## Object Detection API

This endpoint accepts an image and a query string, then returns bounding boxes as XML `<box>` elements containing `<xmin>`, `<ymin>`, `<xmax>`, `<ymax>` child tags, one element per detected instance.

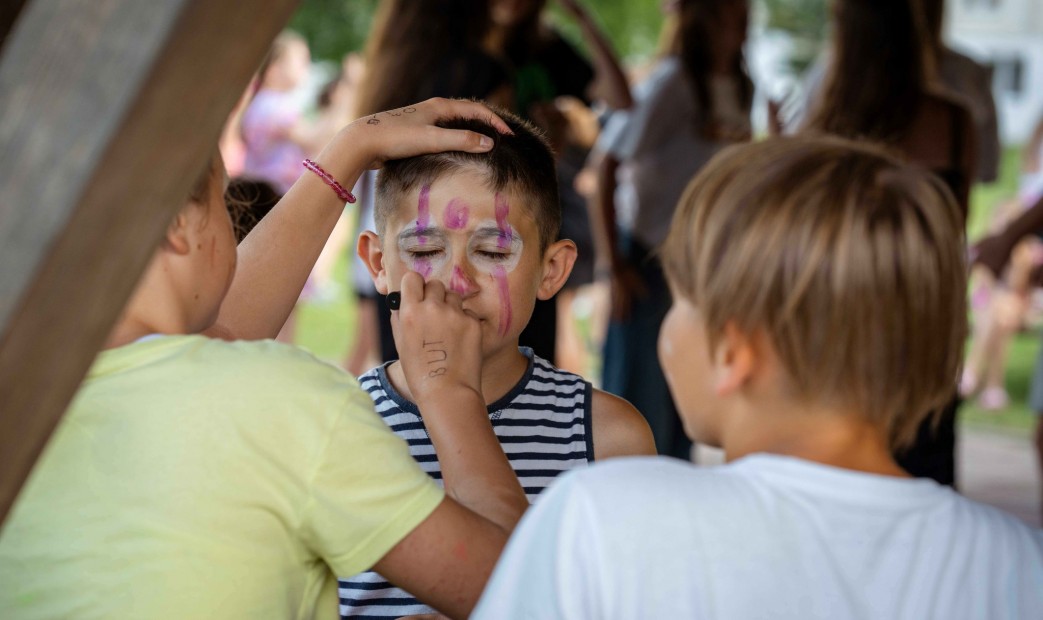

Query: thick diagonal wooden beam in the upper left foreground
<box><xmin>0</xmin><ymin>0</ymin><xmax>296</xmax><ymax>523</ymax></box>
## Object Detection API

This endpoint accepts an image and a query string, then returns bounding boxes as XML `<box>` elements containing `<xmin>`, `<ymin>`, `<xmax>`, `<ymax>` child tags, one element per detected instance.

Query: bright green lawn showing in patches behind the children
<box><xmin>297</xmin><ymin>148</ymin><xmax>1040</xmax><ymax>434</ymax></box>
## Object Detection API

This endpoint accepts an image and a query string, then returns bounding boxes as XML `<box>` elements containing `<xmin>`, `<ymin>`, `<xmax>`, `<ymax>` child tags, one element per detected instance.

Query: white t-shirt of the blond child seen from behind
<box><xmin>472</xmin><ymin>455</ymin><xmax>1043</xmax><ymax>620</ymax></box>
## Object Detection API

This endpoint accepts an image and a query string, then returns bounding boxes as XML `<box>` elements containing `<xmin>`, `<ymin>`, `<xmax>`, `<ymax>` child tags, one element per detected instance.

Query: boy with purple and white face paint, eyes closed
<box><xmin>340</xmin><ymin>113</ymin><xmax>655</xmax><ymax>618</ymax></box>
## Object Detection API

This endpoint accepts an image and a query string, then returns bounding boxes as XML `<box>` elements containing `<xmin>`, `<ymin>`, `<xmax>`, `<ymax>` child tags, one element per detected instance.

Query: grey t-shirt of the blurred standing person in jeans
<box><xmin>598</xmin><ymin>56</ymin><xmax>750</xmax><ymax>248</ymax></box>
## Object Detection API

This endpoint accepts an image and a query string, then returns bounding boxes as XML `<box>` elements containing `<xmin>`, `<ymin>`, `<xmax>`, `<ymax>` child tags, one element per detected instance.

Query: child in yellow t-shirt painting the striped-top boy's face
<box><xmin>0</xmin><ymin>100</ymin><xmax>528</xmax><ymax>618</ymax></box>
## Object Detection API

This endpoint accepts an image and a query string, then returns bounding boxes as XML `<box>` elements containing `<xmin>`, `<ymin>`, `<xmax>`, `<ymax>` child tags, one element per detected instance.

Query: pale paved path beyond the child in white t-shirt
<box><xmin>696</xmin><ymin>427</ymin><xmax>1043</xmax><ymax>527</ymax></box>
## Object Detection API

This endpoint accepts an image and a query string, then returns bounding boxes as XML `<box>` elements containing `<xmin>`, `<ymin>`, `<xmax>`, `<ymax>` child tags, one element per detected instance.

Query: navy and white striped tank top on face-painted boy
<box><xmin>338</xmin><ymin>348</ymin><xmax>593</xmax><ymax>619</ymax></box>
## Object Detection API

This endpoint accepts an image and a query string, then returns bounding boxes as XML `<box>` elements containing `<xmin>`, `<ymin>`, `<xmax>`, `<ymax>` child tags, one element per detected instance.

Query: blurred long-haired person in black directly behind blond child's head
<box><xmin>802</xmin><ymin>0</ymin><xmax>978</xmax><ymax>485</ymax></box>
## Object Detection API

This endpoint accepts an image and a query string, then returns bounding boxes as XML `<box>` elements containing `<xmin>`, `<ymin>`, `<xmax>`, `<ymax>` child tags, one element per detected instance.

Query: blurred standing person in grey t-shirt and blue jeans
<box><xmin>591</xmin><ymin>0</ymin><xmax>753</xmax><ymax>460</ymax></box>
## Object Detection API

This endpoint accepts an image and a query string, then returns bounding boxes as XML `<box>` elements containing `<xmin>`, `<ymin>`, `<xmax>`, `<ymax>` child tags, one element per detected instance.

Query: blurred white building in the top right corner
<box><xmin>946</xmin><ymin>0</ymin><xmax>1043</xmax><ymax>144</ymax></box>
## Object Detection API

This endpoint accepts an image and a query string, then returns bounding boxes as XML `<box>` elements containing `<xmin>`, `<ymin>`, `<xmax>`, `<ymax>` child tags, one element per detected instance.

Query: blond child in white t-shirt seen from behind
<box><xmin>472</xmin><ymin>138</ymin><xmax>1043</xmax><ymax>620</ymax></box>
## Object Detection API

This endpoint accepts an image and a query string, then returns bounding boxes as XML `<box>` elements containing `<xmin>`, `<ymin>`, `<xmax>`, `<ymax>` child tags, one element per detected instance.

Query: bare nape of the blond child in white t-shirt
<box><xmin>721</xmin><ymin>401</ymin><xmax>909</xmax><ymax>477</ymax></box>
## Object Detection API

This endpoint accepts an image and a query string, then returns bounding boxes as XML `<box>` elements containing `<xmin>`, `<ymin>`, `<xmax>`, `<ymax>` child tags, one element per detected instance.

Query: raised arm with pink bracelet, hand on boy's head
<box><xmin>207</xmin><ymin>99</ymin><xmax>510</xmax><ymax>339</ymax></box>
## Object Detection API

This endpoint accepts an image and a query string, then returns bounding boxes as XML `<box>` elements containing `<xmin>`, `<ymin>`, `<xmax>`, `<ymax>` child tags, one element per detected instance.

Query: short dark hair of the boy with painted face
<box><xmin>373</xmin><ymin>110</ymin><xmax>561</xmax><ymax>253</ymax></box>
